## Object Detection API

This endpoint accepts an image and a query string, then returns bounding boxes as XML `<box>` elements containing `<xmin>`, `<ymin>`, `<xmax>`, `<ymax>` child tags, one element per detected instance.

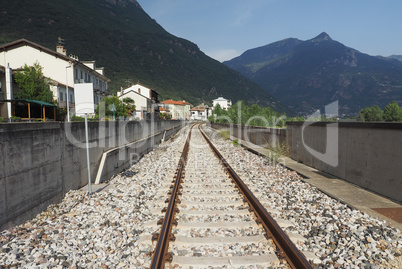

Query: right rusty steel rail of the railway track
<box><xmin>198</xmin><ymin>126</ymin><xmax>313</xmax><ymax>269</ymax></box>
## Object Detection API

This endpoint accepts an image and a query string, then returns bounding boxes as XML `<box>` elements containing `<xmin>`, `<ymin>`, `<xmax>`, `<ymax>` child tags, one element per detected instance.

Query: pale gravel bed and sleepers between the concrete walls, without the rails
<box><xmin>0</xmin><ymin>125</ymin><xmax>402</xmax><ymax>269</ymax></box>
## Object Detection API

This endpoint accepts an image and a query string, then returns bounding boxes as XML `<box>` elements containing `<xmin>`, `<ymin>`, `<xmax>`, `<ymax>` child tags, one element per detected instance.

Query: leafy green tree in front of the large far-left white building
<box><xmin>14</xmin><ymin>62</ymin><xmax>54</xmax><ymax>103</ymax></box>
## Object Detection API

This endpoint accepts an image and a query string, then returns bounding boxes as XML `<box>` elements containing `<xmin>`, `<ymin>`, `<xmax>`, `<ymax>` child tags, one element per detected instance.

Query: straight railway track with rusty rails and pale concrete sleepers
<box><xmin>151</xmin><ymin>126</ymin><xmax>311</xmax><ymax>268</ymax></box>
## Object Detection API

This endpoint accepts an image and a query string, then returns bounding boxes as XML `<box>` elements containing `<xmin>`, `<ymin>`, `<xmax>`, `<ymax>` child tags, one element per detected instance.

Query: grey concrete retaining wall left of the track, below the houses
<box><xmin>0</xmin><ymin>121</ymin><xmax>183</xmax><ymax>231</ymax></box>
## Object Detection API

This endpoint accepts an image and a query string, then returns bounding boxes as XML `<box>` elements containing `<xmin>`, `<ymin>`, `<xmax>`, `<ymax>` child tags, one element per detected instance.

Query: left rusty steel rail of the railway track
<box><xmin>150</xmin><ymin>125</ymin><xmax>194</xmax><ymax>269</ymax></box>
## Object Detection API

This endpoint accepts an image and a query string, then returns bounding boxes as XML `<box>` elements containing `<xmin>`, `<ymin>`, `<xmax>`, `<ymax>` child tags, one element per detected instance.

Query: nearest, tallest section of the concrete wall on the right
<box><xmin>287</xmin><ymin>122</ymin><xmax>402</xmax><ymax>202</ymax></box>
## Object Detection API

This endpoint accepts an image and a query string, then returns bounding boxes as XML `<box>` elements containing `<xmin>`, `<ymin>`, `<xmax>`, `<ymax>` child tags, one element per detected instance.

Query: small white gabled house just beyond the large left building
<box><xmin>117</xmin><ymin>84</ymin><xmax>158</xmax><ymax>120</ymax></box>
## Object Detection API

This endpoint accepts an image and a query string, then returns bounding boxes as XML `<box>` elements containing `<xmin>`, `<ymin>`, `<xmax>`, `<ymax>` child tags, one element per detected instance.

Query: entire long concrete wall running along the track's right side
<box><xmin>211</xmin><ymin>122</ymin><xmax>402</xmax><ymax>203</ymax></box>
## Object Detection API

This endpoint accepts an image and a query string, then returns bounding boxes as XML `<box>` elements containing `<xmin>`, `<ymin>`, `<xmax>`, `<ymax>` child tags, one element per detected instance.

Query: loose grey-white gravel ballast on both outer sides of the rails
<box><xmin>0</xmin><ymin>124</ymin><xmax>402</xmax><ymax>268</ymax></box>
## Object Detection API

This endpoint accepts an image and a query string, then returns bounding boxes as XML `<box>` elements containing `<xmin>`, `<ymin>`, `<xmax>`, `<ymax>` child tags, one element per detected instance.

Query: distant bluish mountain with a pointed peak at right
<box><xmin>224</xmin><ymin>33</ymin><xmax>402</xmax><ymax>115</ymax></box>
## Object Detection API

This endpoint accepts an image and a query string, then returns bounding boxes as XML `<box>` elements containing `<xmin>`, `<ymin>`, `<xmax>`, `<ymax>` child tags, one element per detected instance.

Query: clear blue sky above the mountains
<box><xmin>137</xmin><ymin>0</ymin><xmax>402</xmax><ymax>61</ymax></box>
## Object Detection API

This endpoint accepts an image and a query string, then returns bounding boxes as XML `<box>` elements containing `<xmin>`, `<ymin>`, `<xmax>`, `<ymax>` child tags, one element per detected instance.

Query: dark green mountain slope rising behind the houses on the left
<box><xmin>0</xmin><ymin>0</ymin><xmax>287</xmax><ymax>111</ymax></box>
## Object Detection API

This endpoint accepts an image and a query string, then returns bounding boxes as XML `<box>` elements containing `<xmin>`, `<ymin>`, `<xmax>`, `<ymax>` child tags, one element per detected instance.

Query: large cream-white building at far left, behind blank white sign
<box><xmin>0</xmin><ymin>39</ymin><xmax>110</xmax><ymax>118</ymax></box>
